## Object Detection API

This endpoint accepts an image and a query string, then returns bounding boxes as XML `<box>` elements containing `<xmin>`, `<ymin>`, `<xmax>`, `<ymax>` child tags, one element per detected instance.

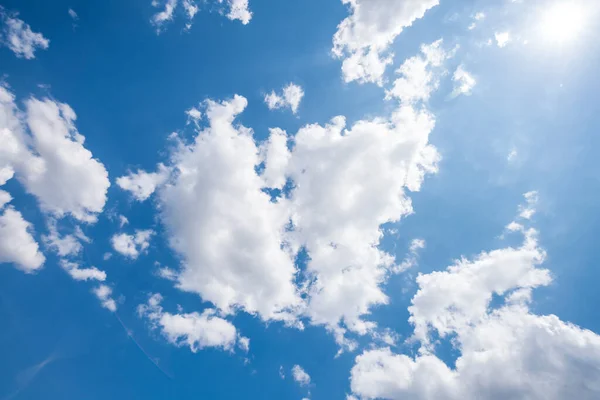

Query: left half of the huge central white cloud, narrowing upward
<box><xmin>158</xmin><ymin>96</ymin><xmax>300</xmax><ymax>319</ymax></box>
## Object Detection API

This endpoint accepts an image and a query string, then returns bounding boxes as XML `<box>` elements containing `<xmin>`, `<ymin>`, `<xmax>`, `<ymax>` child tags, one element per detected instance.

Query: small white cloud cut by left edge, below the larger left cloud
<box><xmin>0</xmin><ymin>206</ymin><xmax>46</xmax><ymax>273</ymax></box>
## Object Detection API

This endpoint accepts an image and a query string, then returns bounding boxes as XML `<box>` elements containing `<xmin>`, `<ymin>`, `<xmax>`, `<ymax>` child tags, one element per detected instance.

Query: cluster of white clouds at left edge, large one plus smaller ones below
<box><xmin>0</xmin><ymin>86</ymin><xmax>110</xmax><ymax>272</ymax></box>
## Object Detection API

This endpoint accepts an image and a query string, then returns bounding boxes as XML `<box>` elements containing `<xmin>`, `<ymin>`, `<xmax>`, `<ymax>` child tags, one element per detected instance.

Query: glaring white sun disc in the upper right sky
<box><xmin>541</xmin><ymin>0</ymin><xmax>586</xmax><ymax>43</ymax></box>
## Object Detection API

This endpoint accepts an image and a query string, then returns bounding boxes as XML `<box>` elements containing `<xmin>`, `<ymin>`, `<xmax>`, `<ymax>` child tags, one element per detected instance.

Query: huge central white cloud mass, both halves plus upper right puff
<box><xmin>117</xmin><ymin>41</ymin><xmax>450</xmax><ymax>348</ymax></box>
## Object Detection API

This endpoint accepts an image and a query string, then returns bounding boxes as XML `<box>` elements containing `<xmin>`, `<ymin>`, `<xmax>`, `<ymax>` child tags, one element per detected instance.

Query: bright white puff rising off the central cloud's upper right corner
<box><xmin>386</xmin><ymin>39</ymin><xmax>450</xmax><ymax>104</ymax></box>
